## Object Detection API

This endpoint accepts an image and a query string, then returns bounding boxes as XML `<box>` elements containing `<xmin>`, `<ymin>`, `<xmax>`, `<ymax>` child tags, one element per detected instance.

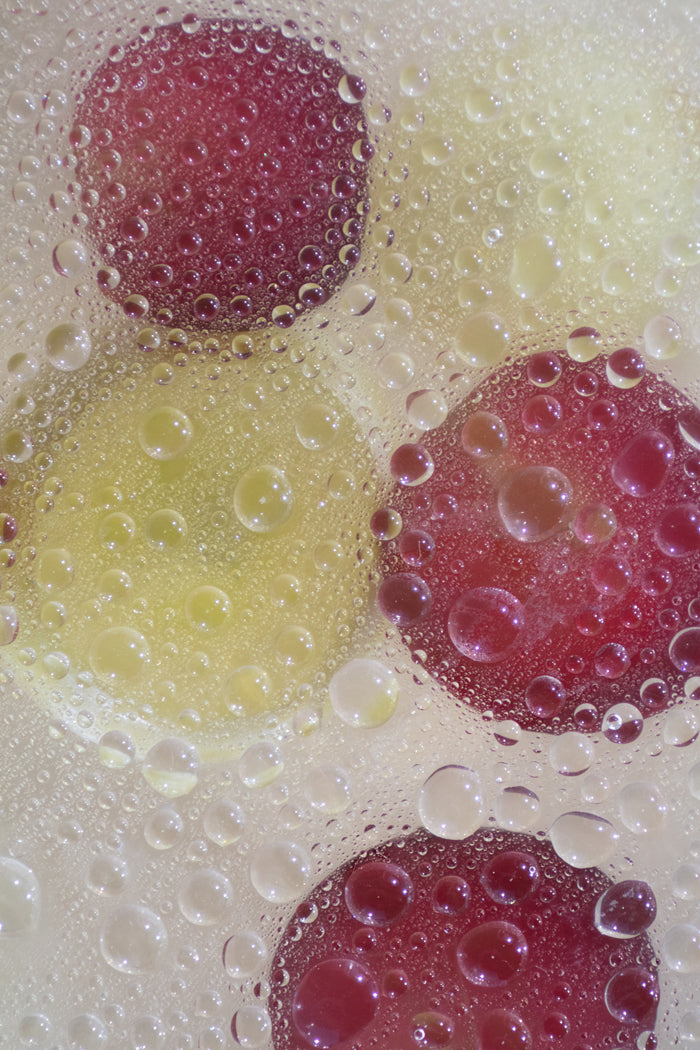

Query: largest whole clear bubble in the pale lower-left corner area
<box><xmin>100</xmin><ymin>904</ymin><xmax>168</xmax><ymax>973</ymax></box>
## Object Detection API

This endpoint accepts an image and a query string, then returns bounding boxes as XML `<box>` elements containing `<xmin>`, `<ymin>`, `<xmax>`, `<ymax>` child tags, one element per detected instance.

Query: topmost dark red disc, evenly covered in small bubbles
<box><xmin>71</xmin><ymin>20</ymin><xmax>373</xmax><ymax>331</ymax></box>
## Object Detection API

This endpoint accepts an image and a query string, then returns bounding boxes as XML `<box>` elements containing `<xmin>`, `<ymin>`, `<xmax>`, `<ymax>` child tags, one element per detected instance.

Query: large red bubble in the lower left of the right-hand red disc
<box><xmin>447</xmin><ymin>587</ymin><xmax>525</xmax><ymax>664</ymax></box>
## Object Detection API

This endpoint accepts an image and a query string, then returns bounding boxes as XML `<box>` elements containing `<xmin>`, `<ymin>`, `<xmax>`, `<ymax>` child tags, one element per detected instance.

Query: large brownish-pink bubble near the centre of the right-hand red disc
<box><xmin>497</xmin><ymin>466</ymin><xmax>573</xmax><ymax>543</ymax></box>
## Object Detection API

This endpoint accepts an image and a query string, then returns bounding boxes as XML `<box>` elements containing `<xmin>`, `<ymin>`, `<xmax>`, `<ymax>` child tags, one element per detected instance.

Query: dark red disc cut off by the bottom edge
<box><xmin>269</xmin><ymin>827</ymin><xmax>658</xmax><ymax>1050</ymax></box>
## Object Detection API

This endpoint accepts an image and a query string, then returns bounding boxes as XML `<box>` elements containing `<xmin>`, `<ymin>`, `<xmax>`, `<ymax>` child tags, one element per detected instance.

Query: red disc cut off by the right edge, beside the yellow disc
<box><xmin>378</xmin><ymin>354</ymin><xmax>700</xmax><ymax>733</ymax></box>
